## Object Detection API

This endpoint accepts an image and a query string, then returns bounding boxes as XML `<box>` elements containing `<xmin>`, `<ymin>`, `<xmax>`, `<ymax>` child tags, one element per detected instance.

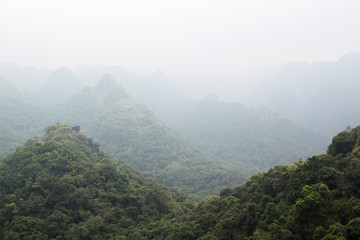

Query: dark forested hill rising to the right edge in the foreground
<box><xmin>172</xmin><ymin>127</ymin><xmax>360</xmax><ymax>240</ymax></box>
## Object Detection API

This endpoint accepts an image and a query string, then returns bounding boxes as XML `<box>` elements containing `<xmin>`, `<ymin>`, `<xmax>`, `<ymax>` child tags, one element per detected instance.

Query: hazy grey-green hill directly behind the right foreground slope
<box><xmin>176</xmin><ymin>94</ymin><xmax>329</xmax><ymax>174</ymax></box>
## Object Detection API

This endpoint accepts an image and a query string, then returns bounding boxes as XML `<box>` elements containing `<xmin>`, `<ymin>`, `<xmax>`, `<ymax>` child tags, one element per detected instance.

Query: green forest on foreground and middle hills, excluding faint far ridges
<box><xmin>0</xmin><ymin>75</ymin><xmax>360</xmax><ymax>240</ymax></box>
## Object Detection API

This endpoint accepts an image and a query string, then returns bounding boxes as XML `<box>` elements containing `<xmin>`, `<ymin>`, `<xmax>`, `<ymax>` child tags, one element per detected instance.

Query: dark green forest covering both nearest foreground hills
<box><xmin>0</xmin><ymin>124</ymin><xmax>360</xmax><ymax>240</ymax></box>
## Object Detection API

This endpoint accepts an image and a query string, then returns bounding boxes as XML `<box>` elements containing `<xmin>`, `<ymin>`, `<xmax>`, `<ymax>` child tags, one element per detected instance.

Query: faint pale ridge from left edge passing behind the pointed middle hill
<box><xmin>0</xmin><ymin>63</ymin><xmax>194</xmax><ymax>122</ymax></box>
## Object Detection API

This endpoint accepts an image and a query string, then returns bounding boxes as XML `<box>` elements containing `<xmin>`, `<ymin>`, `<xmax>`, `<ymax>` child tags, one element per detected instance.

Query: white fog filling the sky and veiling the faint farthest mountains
<box><xmin>0</xmin><ymin>0</ymin><xmax>360</xmax><ymax>132</ymax></box>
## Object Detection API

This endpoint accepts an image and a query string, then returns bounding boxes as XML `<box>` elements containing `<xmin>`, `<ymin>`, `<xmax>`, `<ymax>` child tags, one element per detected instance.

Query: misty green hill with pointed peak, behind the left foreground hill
<box><xmin>47</xmin><ymin>75</ymin><xmax>245</xmax><ymax>194</ymax></box>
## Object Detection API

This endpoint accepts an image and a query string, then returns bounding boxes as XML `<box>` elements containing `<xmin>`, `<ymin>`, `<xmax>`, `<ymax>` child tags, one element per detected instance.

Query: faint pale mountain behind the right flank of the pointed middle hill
<box><xmin>75</xmin><ymin>66</ymin><xmax>195</xmax><ymax>123</ymax></box>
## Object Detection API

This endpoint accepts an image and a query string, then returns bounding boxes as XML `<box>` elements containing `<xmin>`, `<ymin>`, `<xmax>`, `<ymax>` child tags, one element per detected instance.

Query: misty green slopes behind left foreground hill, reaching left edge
<box><xmin>0</xmin><ymin>79</ymin><xmax>247</xmax><ymax>195</ymax></box>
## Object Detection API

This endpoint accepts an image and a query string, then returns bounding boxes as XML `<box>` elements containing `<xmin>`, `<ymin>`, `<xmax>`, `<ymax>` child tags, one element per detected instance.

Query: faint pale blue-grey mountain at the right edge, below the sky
<box><xmin>250</xmin><ymin>52</ymin><xmax>360</xmax><ymax>134</ymax></box>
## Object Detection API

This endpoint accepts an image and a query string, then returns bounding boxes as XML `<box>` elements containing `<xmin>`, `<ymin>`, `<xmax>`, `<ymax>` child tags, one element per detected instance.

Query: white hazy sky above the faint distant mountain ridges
<box><xmin>0</xmin><ymin>0</ymin><xmax>360</xmax><ymax>76</ymax></box>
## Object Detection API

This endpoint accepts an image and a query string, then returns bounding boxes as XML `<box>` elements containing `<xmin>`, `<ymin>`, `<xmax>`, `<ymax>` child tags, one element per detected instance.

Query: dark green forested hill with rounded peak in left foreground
<box><xmin>0</xmin><ymin>124</ymin><xmax>198</xmax><ymax>239</ymax></box>
